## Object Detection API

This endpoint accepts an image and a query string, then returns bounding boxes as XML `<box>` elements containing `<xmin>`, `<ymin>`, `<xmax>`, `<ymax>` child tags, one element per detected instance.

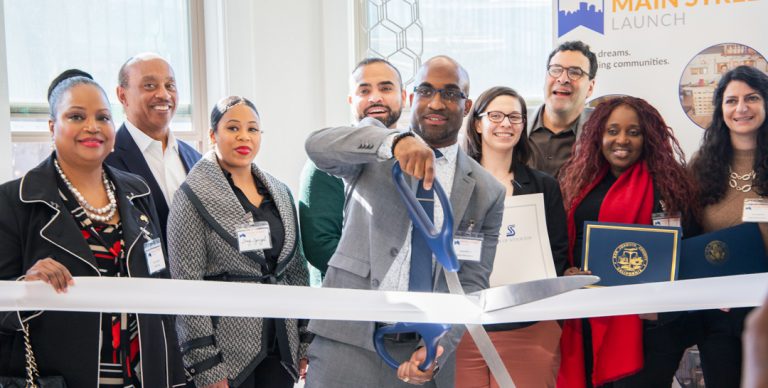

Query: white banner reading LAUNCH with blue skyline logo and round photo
<box><xmin>553</xmin><ymin>0</ymin><xmax>768</xmax><ymax>158</ymax></box>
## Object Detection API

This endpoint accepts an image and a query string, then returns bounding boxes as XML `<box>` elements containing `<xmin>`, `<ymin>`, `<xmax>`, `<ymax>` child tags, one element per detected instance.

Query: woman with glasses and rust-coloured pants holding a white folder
<box><xmin>456</xmin><ymin>86</ymin><xmax>568</xmax><ymax>388</ymax></box>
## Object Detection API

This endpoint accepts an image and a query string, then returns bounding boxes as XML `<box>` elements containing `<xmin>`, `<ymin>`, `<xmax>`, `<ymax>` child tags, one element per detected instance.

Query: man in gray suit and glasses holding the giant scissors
<box><xmin>306</xmin><ymin>56</ymin><xmax>505</xmax><ymax>388</ymax></box>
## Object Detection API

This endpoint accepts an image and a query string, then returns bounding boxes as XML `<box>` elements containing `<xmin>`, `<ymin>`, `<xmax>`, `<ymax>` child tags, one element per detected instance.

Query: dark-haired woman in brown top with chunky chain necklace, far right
<box><xmin>691</xmin><ymin>66</ymin><xmax>768</xmax><ymax>248</ymax></box>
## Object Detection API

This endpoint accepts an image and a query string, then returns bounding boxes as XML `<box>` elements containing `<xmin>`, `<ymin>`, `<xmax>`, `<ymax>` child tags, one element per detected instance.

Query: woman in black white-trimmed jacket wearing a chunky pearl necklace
<box><xmin>0</xmin><ymin>71</ymin><xmax>185</xmax><ymax>387</ymax></box>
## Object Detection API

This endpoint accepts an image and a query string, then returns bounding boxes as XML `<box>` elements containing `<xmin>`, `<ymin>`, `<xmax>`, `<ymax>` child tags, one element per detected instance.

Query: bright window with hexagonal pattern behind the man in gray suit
<box><xmin>357</xmin><ymin>0</ymin><xmax>553</xmax><ymax>104</ymax></box>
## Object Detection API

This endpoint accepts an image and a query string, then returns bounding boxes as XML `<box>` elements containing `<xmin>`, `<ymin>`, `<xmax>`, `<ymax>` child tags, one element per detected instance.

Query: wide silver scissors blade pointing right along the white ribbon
<box><xmin>470</xmin><ymin>275</ymin><xmax>600</xmax><ymax>312</ymax></box>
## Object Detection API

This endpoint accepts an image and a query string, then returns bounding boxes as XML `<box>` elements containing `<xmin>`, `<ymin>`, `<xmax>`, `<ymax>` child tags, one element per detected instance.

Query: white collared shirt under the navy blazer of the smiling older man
<box><xmin>125</xmin><ymin>120</ymin><xmax>187</xmax><ymax>207</ymax></box>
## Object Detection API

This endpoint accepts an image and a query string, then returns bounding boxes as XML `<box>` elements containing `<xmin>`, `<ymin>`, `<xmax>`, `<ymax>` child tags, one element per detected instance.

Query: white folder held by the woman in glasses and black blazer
<box><xmin>491</xmin><ymin>193</ymin><xmax>557</xmax><ymax>287</ymax></box>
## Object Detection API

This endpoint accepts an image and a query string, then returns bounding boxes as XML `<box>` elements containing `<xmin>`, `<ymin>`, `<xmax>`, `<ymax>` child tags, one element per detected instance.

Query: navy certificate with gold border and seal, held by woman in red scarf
<box><xmin>582</xmin><ymin>221</ymin><xmax>682</xmax><ymax>286</ymax></box>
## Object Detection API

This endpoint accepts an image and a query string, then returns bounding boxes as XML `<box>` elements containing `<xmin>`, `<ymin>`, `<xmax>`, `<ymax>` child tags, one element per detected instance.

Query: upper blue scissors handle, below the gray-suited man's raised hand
<box><xmin>392</xmin><ymin>161</ymin><xmax>459</xmax><ymax>272</ymax></box>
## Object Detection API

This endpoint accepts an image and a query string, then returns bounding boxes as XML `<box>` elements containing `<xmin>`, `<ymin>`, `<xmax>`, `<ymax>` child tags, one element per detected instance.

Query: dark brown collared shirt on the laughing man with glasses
<box><xmin>528</xmin><ymin>105</ymin><xmax>592</xmax><ymax>177</ymax></box>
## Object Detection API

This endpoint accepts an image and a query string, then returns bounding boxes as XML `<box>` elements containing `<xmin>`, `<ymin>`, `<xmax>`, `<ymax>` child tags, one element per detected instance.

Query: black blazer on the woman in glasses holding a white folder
<box><xmin>512</xmin><ymin>164</ymin><xmax>568</xmax><ymax>276</ymax></box>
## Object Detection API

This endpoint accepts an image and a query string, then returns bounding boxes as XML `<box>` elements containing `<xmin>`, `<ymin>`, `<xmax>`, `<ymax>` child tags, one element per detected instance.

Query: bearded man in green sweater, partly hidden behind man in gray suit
<box><xmin>299</xmin><ymin>58</ymin><xmax>405</xmax><ymax>276</ymax></box>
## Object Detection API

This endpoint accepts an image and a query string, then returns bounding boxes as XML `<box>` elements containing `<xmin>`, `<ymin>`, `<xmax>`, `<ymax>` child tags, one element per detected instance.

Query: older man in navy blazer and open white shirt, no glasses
<box><xmin>106</xmin><ymin>53</ymin><xmax>201</xmax><ymax>240</ymax></box>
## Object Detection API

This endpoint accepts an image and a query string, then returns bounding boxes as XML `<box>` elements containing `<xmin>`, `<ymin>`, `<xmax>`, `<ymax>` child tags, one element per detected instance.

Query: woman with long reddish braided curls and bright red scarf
<box><xmin>558</xmin><ymin>97</ymin><xmax>696</xmax><ymax>388</ymax></box>
